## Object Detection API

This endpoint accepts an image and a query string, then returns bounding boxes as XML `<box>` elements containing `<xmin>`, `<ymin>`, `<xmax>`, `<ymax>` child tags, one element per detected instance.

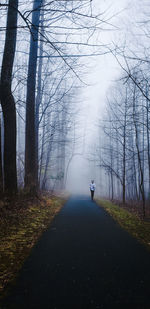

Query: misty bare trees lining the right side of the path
<box><xmin>86</xmin><ymin>4</ymin><xmax>150</xmax><ymax>217</ymax></box>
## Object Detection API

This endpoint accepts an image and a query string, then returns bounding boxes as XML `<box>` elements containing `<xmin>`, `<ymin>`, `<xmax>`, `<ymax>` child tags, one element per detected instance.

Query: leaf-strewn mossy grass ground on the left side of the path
<box><xmin>0</xmin><ymin>196</ymin><xmax>65</xmax><ymax>297</ymax></box>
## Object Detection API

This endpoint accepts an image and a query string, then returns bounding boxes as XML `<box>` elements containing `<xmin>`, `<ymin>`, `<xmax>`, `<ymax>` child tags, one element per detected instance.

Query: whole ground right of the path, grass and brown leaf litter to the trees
<box><xmin>97</xmin><ymin>199</ymin><xmax>150</xmax><ymax>250</ymax></box>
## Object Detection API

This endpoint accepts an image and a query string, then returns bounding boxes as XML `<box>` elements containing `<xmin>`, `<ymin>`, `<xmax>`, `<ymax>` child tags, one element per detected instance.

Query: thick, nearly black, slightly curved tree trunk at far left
<box><xmin>1</xmin><ymin>0</ymin><xmax>18</xmax><ymax>194</ymax></box>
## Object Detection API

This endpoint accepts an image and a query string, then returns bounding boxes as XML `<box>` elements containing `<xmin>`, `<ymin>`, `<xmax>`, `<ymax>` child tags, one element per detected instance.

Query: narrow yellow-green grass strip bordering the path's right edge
<box><xmin>97</xmin><ymin>199</ymin><xmax>150</xmax><ymax>249</ymax></box>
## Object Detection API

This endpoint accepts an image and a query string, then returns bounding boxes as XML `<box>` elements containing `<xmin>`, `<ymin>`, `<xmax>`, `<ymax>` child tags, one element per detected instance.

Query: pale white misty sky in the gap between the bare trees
<box><xmin>68</xmin><ymin>0</ymin><xmax>143</xmax><ymax>193</ymax></box>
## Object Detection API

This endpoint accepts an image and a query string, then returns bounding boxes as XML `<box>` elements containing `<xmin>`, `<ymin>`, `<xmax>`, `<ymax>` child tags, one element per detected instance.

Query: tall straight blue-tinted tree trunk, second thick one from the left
<box><xmin>25</xmin><ymin>0</ymin><xmax>42</xmax><ymax>194</ymax></box>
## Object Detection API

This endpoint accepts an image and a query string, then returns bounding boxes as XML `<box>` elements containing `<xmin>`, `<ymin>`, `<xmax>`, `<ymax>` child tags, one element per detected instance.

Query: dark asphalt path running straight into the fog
<box><xmin>2</xmin><ymin>197</ymin><xmax>150</xmax><ymax>309</ymax></box>
